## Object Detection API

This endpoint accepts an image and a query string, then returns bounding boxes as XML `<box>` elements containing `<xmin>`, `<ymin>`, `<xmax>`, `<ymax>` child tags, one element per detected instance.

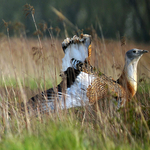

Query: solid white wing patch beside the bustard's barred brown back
<box><xmin>61</xmin><ymin>72</ymin><xmax>95</xmax><ymax>109</ymax></box>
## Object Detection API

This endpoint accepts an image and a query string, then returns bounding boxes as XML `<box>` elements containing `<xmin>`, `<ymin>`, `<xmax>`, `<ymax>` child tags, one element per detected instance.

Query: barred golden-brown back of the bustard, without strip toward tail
<box><xmin>87</xmin><ymin>75</ymin><xmax>126</xmax><ymax>107</ymax></box>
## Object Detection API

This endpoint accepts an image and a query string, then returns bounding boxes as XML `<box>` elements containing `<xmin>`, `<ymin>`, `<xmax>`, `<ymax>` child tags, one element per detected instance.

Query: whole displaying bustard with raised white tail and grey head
<box><xmin>30</xmin><ymin>34</ymin><xmax>148</xmax><ymax>111</ymax></box>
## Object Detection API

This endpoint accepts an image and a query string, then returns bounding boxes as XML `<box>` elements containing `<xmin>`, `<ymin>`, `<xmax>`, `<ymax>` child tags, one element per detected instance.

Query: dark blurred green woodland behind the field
<box><xmin>0</xmin><ymin>0</ymin><xmax>150</xmax><ymax>42</ymax></box>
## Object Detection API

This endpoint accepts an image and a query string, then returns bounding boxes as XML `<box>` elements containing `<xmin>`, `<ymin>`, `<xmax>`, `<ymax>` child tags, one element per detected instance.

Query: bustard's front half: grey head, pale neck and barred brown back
<box><xmin>87</xmin><ymin>48</ymin><xmax>148</xmax><ymax>108</ymax></box>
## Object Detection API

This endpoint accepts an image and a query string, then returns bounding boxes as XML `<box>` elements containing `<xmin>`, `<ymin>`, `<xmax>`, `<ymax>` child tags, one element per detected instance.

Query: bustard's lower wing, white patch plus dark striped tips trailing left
<box><xmin>30</xmin><ymin>69</ymin><xmax>95</xmax><ymax>111</ymax></box>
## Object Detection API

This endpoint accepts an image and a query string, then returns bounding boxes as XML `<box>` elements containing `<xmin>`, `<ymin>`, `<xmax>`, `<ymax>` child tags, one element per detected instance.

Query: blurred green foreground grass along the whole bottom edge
<box><xmin>0</xmin><ymin>116</ymin><xmax>148</xmax><ymax>150</ymax></box>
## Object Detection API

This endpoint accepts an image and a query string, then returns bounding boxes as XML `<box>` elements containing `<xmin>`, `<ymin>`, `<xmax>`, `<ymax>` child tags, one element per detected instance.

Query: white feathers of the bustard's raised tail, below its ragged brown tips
<box><xmin>62</xmin><ymin>43</ymin><xmax>88</xmax><ymax>71</ymax></box>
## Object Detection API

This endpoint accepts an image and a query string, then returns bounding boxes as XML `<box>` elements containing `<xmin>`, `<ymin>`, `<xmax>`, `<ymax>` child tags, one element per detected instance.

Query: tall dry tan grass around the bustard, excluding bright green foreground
<box><xmin>0</xmin><ymin>33</ymin><xmax>150</xmax><ymax>148</ymax></box>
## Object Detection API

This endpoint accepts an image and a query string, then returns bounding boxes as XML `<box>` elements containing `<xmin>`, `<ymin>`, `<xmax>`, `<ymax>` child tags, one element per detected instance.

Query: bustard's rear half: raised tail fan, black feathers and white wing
<box><xmin>29</xmin><ymin>34</ymin><xmax>94</xmax><ymax>111</ymax></box>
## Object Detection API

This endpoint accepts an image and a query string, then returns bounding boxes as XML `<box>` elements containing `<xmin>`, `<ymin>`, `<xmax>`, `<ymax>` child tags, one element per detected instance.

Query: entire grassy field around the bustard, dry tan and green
<box><xmin>0</xmin><ymin>33</ymin><xmax>150</xmax><ymax>150</ymax></box>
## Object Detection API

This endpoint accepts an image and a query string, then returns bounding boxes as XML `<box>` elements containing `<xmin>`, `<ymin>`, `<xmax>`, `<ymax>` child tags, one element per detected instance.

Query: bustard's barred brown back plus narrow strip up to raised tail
<box><xmin>70</xmin><ymin>60</ymin><xmax>127</xmax><ymax>108</ymax></box>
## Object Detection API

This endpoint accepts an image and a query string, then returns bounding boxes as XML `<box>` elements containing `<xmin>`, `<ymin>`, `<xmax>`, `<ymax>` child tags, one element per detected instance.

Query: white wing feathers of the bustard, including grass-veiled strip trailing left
<box><xmin>42</xmin><ymin>72</ymin><xmax>95</xmax><ymax>111</ymax></box>
